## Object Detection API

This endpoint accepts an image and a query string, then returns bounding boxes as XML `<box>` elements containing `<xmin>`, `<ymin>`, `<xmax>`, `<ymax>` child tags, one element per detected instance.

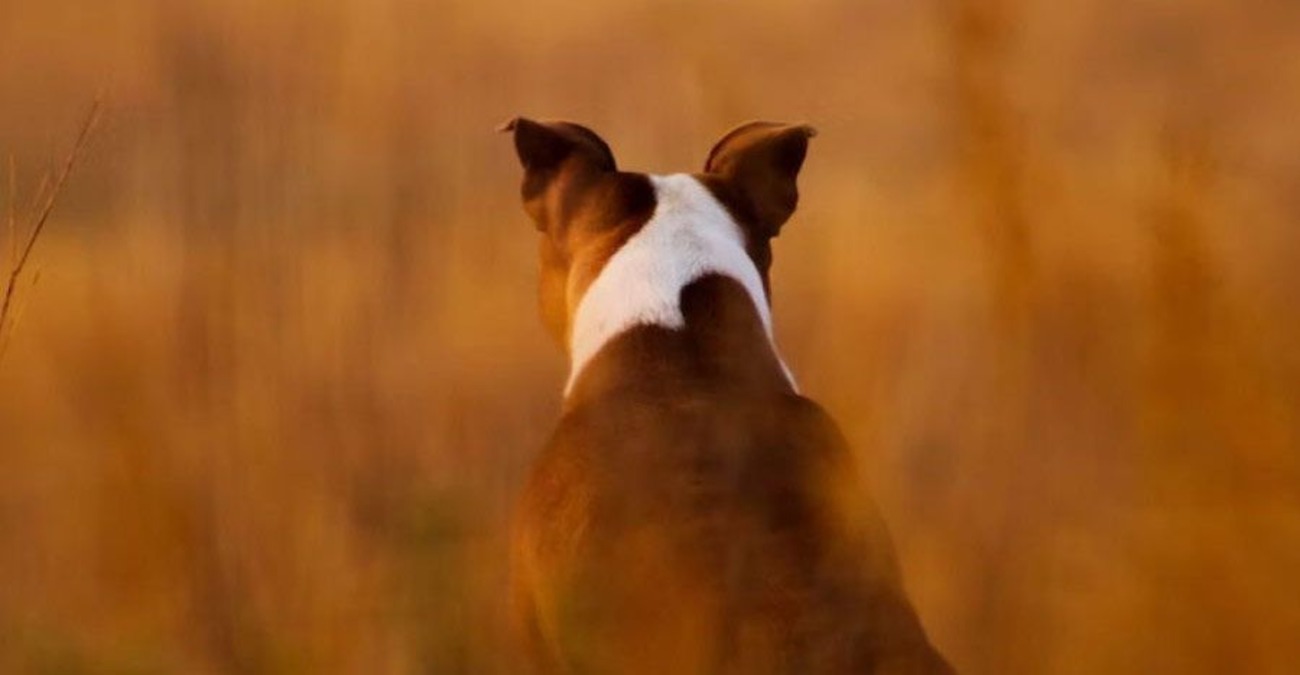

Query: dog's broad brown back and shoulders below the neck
<box><xmin>516</xmin><ymin>394</ymin><xmax>945</xmax><ymax>674</ymax></box>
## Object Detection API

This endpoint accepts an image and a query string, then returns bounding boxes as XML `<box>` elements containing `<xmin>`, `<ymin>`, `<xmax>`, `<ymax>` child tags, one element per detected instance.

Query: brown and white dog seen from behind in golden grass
<box><xmin>503</xmin><ymin>118</ymin><xmax>952</xmax><ymax>675</ymax></box>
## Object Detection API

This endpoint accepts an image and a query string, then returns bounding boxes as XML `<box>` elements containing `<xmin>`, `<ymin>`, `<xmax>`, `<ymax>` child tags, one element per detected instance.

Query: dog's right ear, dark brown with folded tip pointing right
<box><xmin>705</xmin><ymin>122</ymin><xmax>816</xmax><ymax>237</ymax></box>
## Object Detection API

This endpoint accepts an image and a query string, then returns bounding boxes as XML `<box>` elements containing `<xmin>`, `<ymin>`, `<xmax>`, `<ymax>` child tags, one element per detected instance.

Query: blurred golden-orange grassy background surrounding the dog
<box><xmin>0</xmin><ymin>0</ymin><xmax>1300</xmax><ymax>674</ymax></box>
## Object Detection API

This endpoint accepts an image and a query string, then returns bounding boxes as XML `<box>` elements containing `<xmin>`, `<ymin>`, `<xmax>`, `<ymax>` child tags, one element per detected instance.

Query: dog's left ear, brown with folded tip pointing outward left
<box><xmin>498</xmin><ymin>117</ymin><xmax>618</xmax><ymax>232</ymax></box>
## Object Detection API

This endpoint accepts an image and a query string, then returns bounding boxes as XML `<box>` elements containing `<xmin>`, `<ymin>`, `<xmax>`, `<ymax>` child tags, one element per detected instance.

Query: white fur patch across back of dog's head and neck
<box><xmin>564</xmin><ymin>174</ymin><xmax>794</xmax><ymax>395</ymax></box>
